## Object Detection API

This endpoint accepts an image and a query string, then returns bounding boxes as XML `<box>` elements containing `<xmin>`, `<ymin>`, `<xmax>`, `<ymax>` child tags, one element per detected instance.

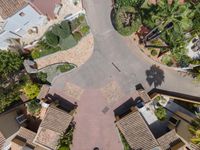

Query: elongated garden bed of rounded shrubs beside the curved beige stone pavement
<box><xmin>31</xmin><ymin>14</ymin><xmax>89</xmax><ymax>59</ymax></box>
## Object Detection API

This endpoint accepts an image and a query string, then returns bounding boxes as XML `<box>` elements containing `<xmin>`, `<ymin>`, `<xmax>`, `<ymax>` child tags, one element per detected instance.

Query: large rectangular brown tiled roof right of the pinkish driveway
<box><xmin>116</xmin><ymin>112</ymin><xmax>159</xmax><ymax>150</ymax></box>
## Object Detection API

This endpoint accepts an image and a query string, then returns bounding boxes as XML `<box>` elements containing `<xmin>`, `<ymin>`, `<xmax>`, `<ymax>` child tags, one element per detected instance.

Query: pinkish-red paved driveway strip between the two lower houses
<box><xmin>72</xmin><ymin>90</ymin><xmax>123</xmax><ymax>150</ymax></box>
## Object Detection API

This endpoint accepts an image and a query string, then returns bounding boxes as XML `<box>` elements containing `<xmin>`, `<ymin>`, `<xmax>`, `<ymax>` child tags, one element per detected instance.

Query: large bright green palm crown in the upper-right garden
<box><xmin>152</xmin><ymin>0</ymin><xmax>194</xmax><ymax>32</ymax></box>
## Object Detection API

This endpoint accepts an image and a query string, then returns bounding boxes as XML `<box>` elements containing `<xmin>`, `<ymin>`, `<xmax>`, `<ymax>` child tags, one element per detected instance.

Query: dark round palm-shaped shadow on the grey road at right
<box><xmin>146</xmin><ymin>65</ymin><xmax>165</xmax><ymax>88</ymax></box>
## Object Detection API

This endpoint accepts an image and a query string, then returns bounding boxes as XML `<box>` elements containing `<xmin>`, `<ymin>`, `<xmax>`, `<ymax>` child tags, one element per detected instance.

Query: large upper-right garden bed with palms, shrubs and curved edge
<box><xmin>113</xmin><ymin>0</ymin><xmax>200</xmax><ymax>67</ymax></box>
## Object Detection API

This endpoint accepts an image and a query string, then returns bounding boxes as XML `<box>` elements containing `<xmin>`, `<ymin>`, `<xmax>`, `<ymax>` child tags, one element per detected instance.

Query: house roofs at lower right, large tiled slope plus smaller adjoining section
<box><xmin>116</xmin><ymin>109</ymin><xmax>188</xmax><ymax>150</ymax></box>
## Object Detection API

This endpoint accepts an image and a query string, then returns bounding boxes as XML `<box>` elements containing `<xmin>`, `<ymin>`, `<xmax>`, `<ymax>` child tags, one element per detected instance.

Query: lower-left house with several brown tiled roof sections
<box><xmin>0</xmin><ymin>105</ymin><xmax>73</xmax><ymax>150</ymax></box>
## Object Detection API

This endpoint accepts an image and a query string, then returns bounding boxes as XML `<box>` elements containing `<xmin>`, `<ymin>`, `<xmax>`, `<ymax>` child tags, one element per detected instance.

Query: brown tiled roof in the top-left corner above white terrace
<box><xmin>0</xmin><ymin>0</ymin><xmax>27</xmax><ymax>19</ymax></box>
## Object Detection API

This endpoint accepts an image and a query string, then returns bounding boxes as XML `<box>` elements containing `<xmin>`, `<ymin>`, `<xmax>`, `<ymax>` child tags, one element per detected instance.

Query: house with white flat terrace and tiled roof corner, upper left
<box><xmin>0</xmin><ymin>0</ymin><xmax>46</xmax><ymax>49</ymax></box>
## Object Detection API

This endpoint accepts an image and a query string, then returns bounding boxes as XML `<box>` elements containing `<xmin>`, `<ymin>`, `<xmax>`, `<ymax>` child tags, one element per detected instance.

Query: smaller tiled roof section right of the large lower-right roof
<box><xmin>157</xmin><ymin>130</ymin><xmax>184</xmax><ymax>150</ymax></box>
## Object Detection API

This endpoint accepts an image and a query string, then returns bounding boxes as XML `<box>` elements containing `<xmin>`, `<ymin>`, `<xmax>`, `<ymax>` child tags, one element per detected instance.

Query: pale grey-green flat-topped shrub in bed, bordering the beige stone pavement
<box><xmin>59</xmin><ymin>35</ymin><xmax>77</xmax><ymax>50</ymax></box>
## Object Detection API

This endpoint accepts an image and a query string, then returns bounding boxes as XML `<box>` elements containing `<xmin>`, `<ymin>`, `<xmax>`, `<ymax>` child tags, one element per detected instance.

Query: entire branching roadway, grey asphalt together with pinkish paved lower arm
<box><xmin>51</xmin><ymin>0</ymin><xmax>200</xmax><ymax>150</ymax></box>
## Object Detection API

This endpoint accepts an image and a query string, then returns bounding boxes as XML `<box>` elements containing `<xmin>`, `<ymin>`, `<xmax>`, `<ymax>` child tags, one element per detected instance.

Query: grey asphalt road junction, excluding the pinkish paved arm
<box><xmin>53</xmin><ymin>0</ymin><xmax>200</xmax><ymax>96</ymax></box>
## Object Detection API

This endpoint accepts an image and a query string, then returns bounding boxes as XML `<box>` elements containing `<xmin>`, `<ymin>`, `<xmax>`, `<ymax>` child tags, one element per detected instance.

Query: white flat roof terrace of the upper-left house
<box><xmin>0</xmin><ymin>5</ymin><xmax>46</xmax><ymax>49</ymax></box>
